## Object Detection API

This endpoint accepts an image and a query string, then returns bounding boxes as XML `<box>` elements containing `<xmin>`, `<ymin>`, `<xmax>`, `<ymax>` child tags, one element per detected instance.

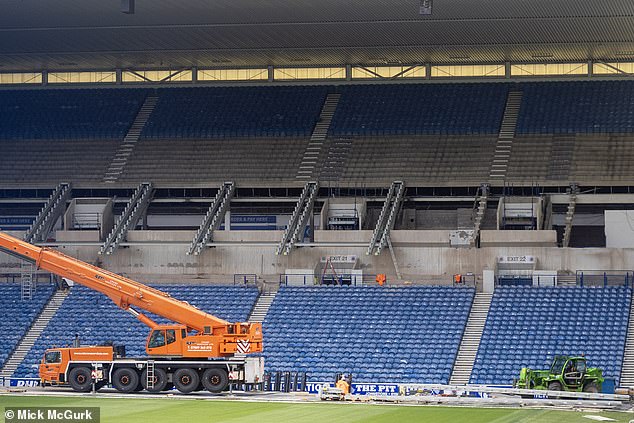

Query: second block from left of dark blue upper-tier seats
<box><xmin>143</xmin><ymin>86</ymin><xmax>328</xmax><ymax>138</ymax></box>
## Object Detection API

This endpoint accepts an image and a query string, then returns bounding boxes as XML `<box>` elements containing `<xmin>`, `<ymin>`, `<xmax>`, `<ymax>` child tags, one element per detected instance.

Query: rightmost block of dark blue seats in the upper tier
<box><xmin>517</xmin><ymin>81</ymin><xmax>634</xmax><ymax>134</ymax></box>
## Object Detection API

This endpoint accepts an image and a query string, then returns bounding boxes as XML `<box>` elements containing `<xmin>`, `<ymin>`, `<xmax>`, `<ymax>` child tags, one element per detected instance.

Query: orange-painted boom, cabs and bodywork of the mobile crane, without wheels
<box><xmin>0</xmin><ymin>232</ymin><xmax>262</xmax><ymax>388</ymax></box>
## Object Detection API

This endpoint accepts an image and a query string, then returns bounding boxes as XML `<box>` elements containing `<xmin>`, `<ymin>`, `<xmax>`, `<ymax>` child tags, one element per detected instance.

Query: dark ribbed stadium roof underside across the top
<box><xmin>0</xmin><ymin>0</ymin><xmax>634</xmax><ymax>72</ymax></box>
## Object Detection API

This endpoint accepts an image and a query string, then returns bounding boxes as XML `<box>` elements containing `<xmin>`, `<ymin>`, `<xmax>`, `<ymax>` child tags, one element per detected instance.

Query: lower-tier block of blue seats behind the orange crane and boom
<box><xmin>14</xmin><ymin>284</ymin><xmax>258</xmax><ymax>377</ymax></box>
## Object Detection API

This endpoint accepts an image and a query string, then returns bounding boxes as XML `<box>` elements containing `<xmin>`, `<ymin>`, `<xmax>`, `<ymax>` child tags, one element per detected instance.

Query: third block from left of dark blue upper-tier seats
<box><xmin>330</xmin><ymin>84</ymin><xmax>508</xmax><ymax>135</ymax></box>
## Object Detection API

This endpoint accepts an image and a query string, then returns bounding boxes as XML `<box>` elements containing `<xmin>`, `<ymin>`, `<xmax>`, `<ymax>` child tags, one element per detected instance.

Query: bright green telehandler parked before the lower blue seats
<box><xmin>513</xmin><ymin>355</ymin><xmax>604</xmax><ymax>393</ymax></box>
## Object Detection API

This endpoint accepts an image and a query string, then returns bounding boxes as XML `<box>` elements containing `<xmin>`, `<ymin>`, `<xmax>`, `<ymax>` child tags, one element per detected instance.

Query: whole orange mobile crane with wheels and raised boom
<box><xmin>0</xmin><ymin>232</ymin><xmax>264</xmax><ymax>393</ymax></box>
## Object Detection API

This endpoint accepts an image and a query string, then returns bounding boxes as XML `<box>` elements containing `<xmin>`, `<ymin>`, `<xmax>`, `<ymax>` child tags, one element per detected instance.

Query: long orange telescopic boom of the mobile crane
<box><xmin>0</xmin><ymin>232</ymin><xmax>231</xmax><ymax>333</ymax></box>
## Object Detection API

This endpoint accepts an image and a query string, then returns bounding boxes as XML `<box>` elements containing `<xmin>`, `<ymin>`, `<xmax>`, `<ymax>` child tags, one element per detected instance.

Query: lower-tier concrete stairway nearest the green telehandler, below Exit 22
<box><xmin>449</xmin><ymin>292</ymin><xmax>493</xmax><ymax>385</ymax></box>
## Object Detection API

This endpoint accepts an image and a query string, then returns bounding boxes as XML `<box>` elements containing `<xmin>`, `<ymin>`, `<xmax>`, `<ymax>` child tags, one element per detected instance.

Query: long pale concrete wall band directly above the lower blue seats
<box><xmin>63</xmin><ymin>244</ymin><xmax>634</xmax><ymax>281</ymax></box>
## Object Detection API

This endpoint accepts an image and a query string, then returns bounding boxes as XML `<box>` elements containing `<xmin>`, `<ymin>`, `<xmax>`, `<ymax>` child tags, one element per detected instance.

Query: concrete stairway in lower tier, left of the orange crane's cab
<box><xmin>0</xmin><ymin>291</ymin><xmax>69</xmax><ymax>378</ymax></box>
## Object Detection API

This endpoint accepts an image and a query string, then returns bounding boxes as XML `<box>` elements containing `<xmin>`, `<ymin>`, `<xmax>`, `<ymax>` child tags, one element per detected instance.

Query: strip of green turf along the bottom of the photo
<box><xmin>0</xmin><ymin>395</ymin><xmax>634</xmax><ymax>423</ymax></box>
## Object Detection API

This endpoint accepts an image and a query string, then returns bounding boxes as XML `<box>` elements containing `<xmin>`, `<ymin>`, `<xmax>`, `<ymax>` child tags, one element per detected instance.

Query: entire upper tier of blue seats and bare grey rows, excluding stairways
<box><xmin>0</xmin><ymin>81</ymin><xmax>634</xmax><ymax>185</ymax></box>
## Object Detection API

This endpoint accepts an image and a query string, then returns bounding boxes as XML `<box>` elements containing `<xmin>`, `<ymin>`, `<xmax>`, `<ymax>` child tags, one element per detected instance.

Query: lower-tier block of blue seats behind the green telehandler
<box><xmin>471</xmin><ymin>287</ymin><xmax>632</xmax><ymax>385</ymax></box>
